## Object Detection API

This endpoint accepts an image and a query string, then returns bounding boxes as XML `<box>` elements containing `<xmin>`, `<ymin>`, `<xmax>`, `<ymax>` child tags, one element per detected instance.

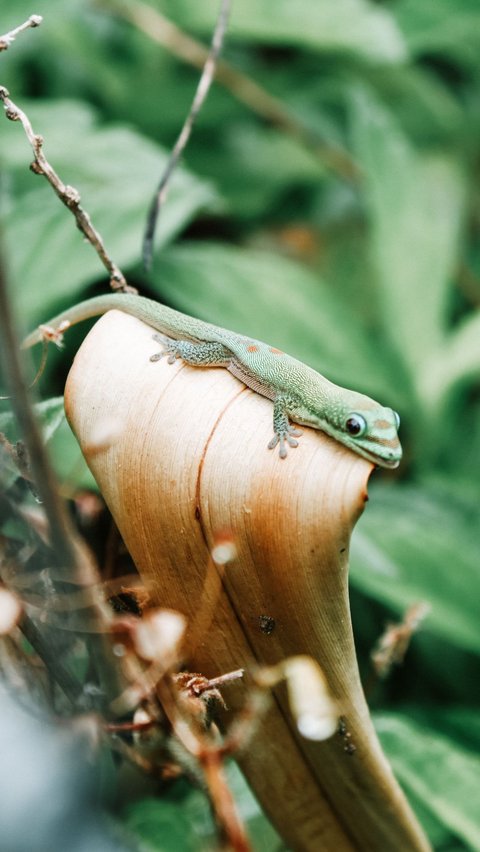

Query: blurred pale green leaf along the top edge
<box><xmin>159</xmin><ymin>0</ymin><xmax>406</xmax><ymax>62</ymax></box>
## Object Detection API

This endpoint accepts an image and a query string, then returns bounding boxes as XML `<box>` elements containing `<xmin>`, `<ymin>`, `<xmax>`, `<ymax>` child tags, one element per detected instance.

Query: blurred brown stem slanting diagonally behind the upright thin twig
<box><xmin>97</xmin><ymin>0</ymin><xmax>359</xmax><ymax>183</ymax></box>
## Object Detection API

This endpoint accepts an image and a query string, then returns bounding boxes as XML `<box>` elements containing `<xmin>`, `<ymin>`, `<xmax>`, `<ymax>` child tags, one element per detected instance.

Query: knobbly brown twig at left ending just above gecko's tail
<box><xmin>0</xmin><ymin>86</ymin><xmax>137</xmax><ymax>293</ymax></box>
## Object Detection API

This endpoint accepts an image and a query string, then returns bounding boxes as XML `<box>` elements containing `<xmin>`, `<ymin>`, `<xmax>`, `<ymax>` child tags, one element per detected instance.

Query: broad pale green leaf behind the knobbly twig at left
<box><xmin>0</xmin><ymin>101</ymin><xmax>217</xmax><ymax>325</ymax></box>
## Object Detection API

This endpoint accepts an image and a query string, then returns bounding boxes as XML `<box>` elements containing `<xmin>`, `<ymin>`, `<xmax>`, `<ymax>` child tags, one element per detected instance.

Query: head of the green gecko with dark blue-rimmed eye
<box><xmin>316</xmin><ymin>391</ymin><xmax>402</xmax><ymax>468</ymax></box>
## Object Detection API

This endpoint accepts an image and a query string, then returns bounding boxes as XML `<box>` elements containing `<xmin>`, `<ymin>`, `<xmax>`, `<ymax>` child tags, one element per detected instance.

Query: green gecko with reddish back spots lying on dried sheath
<box><xmin>23</xmin><ymin>294</ymin><xmax>402</xmax><ymax>468</ymax></box>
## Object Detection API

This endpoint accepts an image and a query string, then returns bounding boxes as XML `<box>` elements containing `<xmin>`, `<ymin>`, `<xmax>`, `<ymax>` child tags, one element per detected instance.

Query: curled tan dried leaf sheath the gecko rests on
<box><xmin>66</xmin><ymin>312</ymin><xmax>429</xmax><ymax>852</ymax></box>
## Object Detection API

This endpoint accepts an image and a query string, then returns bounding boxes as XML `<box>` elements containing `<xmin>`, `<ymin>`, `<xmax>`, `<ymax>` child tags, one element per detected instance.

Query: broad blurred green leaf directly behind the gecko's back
<box><xmin>150</xmin><ymin>243</ymin><xmax>393</xmax><ymax>400</ymax></box>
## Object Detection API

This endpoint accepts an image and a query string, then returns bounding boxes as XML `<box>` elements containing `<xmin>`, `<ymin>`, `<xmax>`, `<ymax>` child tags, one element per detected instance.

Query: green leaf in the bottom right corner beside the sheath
<box><xmin>375</xmin><ymin>713</ymin><xmax>480</xmax><ymax>850</ymax></box>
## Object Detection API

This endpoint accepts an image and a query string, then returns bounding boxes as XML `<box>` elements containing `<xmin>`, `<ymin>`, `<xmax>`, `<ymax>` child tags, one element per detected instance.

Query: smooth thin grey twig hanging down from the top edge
<box><xmin>142</xmin><ymin>0</ymin><xmax>231</xmax><ymax>269</ymax></box>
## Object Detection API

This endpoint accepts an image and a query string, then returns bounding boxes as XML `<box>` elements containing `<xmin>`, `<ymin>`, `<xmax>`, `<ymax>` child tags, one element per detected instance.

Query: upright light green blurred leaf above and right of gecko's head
<box><xmin>352</xmin><ymin>89</ymin><xmax>465</xmax><ymax>382</ymax></box>
